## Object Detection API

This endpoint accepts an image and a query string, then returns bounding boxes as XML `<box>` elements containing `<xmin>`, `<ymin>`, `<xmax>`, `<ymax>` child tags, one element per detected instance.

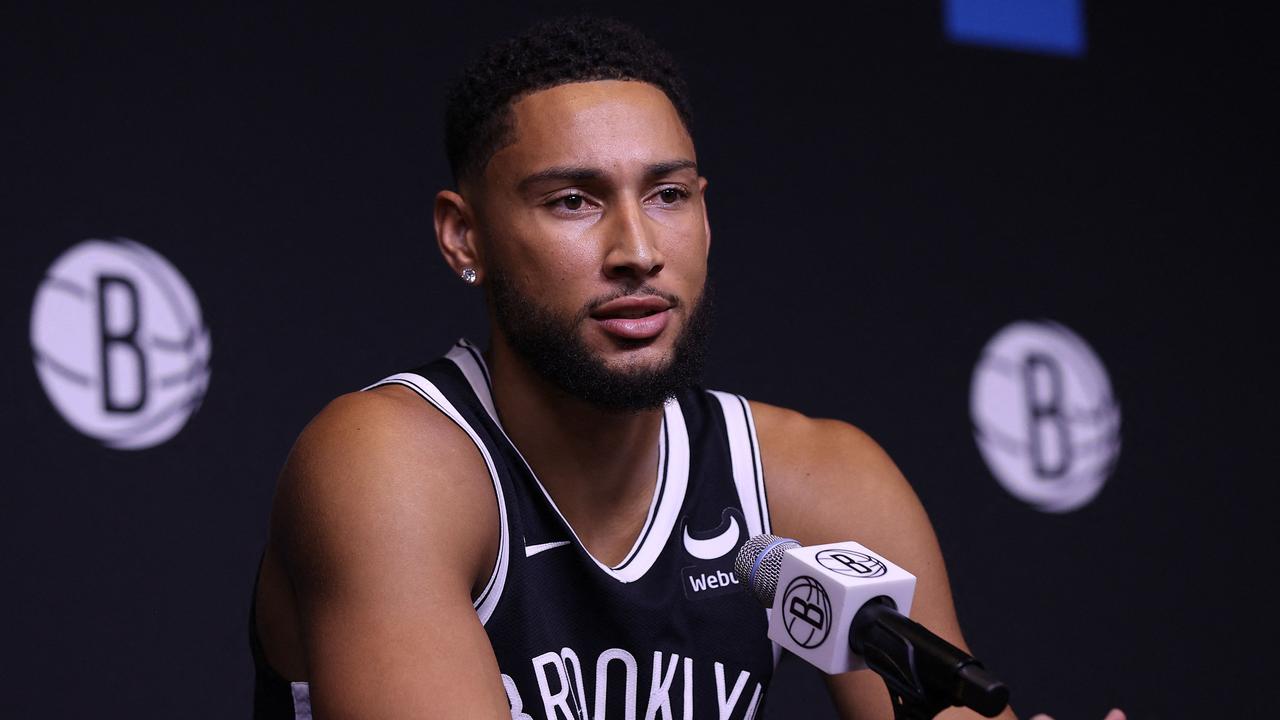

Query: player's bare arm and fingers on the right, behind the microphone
<box><xmin>751</xmin><ymin>402</ymin><xmax>1014</xmax><ymax>720</ymax></box>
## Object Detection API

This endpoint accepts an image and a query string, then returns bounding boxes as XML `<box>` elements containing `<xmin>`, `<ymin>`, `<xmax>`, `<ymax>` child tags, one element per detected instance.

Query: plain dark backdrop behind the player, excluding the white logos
<box><xmin>0</xmin><ymin>1</ymin><xmax>1277</xmax><ymax>720</ymax></box>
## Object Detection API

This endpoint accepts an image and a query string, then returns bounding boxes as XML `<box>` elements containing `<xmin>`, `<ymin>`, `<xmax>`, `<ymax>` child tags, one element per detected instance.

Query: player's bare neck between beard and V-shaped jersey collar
<box><xmin>488</xmin><ymin>333</ymin><xmax>663</xmax><ymax>562</ymax></box>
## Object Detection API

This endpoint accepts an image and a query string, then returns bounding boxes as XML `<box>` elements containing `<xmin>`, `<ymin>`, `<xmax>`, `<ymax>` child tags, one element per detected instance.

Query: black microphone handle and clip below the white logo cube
<box><xmin>849</xmin><ymin>597</ymin><xmax>1009</xmax><ymax>720</ymax></box>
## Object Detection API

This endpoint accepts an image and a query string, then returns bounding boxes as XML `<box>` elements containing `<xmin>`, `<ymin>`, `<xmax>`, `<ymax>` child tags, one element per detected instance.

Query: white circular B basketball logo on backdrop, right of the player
<box><xmin>969</xmin><ymin>320</ymin><xmax>1120</xmax><ymax>512</ymax></box>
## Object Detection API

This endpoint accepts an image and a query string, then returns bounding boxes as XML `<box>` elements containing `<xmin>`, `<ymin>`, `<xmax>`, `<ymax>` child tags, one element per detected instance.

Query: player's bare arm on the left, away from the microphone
<box><xmin>271</xmin><ymin>388</ymin><xmax>511</xmax><ymax>720</ymax></box>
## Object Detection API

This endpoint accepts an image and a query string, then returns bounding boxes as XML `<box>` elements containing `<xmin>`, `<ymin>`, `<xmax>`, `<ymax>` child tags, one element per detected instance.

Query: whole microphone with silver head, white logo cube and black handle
<box><xmin>733</xmin><ymin>534</ymin><xmax>1009</xmax><ymax>717</ymax></box>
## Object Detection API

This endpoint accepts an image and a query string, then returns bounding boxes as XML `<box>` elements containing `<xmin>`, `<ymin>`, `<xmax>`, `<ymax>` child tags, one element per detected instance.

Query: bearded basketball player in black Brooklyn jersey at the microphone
<box><xmin>252</xmin><ymin>20</ymin><xmax>1121</xmax><ymax>720</ymax></box>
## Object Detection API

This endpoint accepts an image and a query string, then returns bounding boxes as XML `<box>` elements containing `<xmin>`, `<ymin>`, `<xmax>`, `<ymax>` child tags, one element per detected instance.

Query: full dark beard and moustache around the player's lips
<box><xmin>485</xmin><ymin>268</ymin><xmax>712</xmax><ymax>413</ymax></box>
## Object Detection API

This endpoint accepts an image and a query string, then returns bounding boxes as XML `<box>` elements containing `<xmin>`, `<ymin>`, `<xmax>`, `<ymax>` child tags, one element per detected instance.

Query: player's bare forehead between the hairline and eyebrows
<box><xmin>486</xmin><ymin>81</ymin><xmax>695</xmax><ymax>179</ymax></box>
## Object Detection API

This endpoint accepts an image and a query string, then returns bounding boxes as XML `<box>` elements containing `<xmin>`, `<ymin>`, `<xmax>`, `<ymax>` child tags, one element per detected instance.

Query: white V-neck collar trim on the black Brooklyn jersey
<box><xmin>445</xmin><ymin>340</ymin><xmax>689</xmax><ymax>583</ymax></box>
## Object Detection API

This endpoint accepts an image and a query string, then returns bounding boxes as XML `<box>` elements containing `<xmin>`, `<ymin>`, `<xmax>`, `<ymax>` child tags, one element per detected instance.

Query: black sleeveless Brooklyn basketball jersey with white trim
<box><xmin>250</xmin><ymin>341</ymin><xmax>777</xmax><ymax>720</ymax></box>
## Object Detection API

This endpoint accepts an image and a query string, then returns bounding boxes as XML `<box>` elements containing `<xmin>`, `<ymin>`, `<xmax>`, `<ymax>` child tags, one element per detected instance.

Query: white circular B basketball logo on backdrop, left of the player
<box><xmin>31</xmin><ymin>238</ymin><xmax>210</xmax><ymax>450</ymax></box>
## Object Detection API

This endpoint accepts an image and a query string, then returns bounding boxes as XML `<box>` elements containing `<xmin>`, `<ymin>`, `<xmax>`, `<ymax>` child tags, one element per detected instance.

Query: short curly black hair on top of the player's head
<box><xmin>444</xmin><ymin>17</ymin><xmax>692</xmax><ymax>189</ymax></box>
